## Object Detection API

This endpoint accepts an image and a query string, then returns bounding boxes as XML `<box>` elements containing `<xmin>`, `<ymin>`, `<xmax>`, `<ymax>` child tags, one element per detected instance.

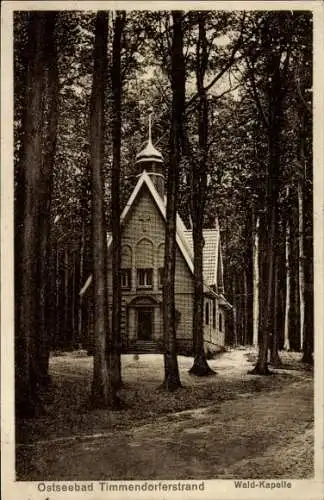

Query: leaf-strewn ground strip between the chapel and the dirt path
<box><xmin>17</xmin><ymin>350</ymin><xmax>311</xmax><ymax>443</ymax></box>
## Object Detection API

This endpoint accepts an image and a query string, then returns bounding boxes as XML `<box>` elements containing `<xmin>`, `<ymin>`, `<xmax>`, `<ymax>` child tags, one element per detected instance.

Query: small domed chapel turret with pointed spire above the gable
<box><xmin>136</xmin><ymin>113</ymin><xmax>165</xmax><ymax>199</ymax></box>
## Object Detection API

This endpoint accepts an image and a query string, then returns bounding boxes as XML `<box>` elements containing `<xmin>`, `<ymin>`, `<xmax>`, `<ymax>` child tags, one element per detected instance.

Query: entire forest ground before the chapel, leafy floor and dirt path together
<box><xmin>16</xmin><ymin>349</ymin><xmax>313</xmax><ymax>481</ymax></box>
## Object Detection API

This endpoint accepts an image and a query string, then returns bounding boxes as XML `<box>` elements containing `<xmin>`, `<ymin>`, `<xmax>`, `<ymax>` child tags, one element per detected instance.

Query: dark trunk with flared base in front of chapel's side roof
<box><xmin>189</xmin><ymin>12</ymin><xmax>215</xmax><ymax>376</ymax></box>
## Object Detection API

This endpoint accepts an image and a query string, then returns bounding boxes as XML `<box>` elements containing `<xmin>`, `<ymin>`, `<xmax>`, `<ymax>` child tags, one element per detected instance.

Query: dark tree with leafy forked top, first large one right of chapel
<box><xmin>246</xmin><ymin>14</ymin><xmax>291</xmax><ymax>375</ymax></box>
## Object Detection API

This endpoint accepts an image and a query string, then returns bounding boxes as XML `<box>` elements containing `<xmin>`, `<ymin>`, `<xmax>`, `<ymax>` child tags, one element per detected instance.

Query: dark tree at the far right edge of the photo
<box><xmin>292</xmin><ymin>12</ymin><xmax>314</xmax><ymax>364</ymax></box>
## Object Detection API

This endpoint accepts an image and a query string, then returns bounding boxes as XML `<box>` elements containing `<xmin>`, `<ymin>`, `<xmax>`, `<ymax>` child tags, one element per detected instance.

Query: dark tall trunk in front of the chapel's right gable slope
<box><xmin>163</xmin><ymin>11</ymin><xmax>185</xmax><ymax>391</ymax></box>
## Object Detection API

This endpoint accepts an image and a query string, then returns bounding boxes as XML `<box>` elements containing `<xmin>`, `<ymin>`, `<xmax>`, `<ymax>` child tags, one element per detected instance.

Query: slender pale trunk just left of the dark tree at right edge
<box><xmin>297</xmin><ymin>181</ymin><xmax>305</xmax><ymax>350</ymax></box>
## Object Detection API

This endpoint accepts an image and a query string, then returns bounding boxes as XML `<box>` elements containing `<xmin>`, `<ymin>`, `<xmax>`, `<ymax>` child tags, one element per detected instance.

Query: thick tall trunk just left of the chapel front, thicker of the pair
<box><xmin>90</xmin><ymin>11</ymin><xmax>115</xmax><ymax>408</ymax></box>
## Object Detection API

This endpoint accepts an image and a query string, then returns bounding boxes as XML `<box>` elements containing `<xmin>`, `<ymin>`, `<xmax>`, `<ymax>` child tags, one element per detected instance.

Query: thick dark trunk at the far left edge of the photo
<box><xmin>15</xmin><ymin>12</ymin><xmax>46</xmax><ymax>416</ymax></box>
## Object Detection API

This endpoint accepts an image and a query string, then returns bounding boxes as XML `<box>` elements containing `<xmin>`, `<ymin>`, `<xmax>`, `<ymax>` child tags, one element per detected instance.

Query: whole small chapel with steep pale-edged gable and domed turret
<box><xmin>108</xmin><ymin>120</ymin><xmax>231</xmax><ymax>355</ymax></box>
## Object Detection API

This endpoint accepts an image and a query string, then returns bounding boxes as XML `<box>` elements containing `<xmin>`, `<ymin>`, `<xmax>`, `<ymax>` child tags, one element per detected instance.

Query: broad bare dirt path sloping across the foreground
<box><xmin>18</xmin><ymin>380</ymin><xmax>313</xmax><ymax>480</ymax></box>
